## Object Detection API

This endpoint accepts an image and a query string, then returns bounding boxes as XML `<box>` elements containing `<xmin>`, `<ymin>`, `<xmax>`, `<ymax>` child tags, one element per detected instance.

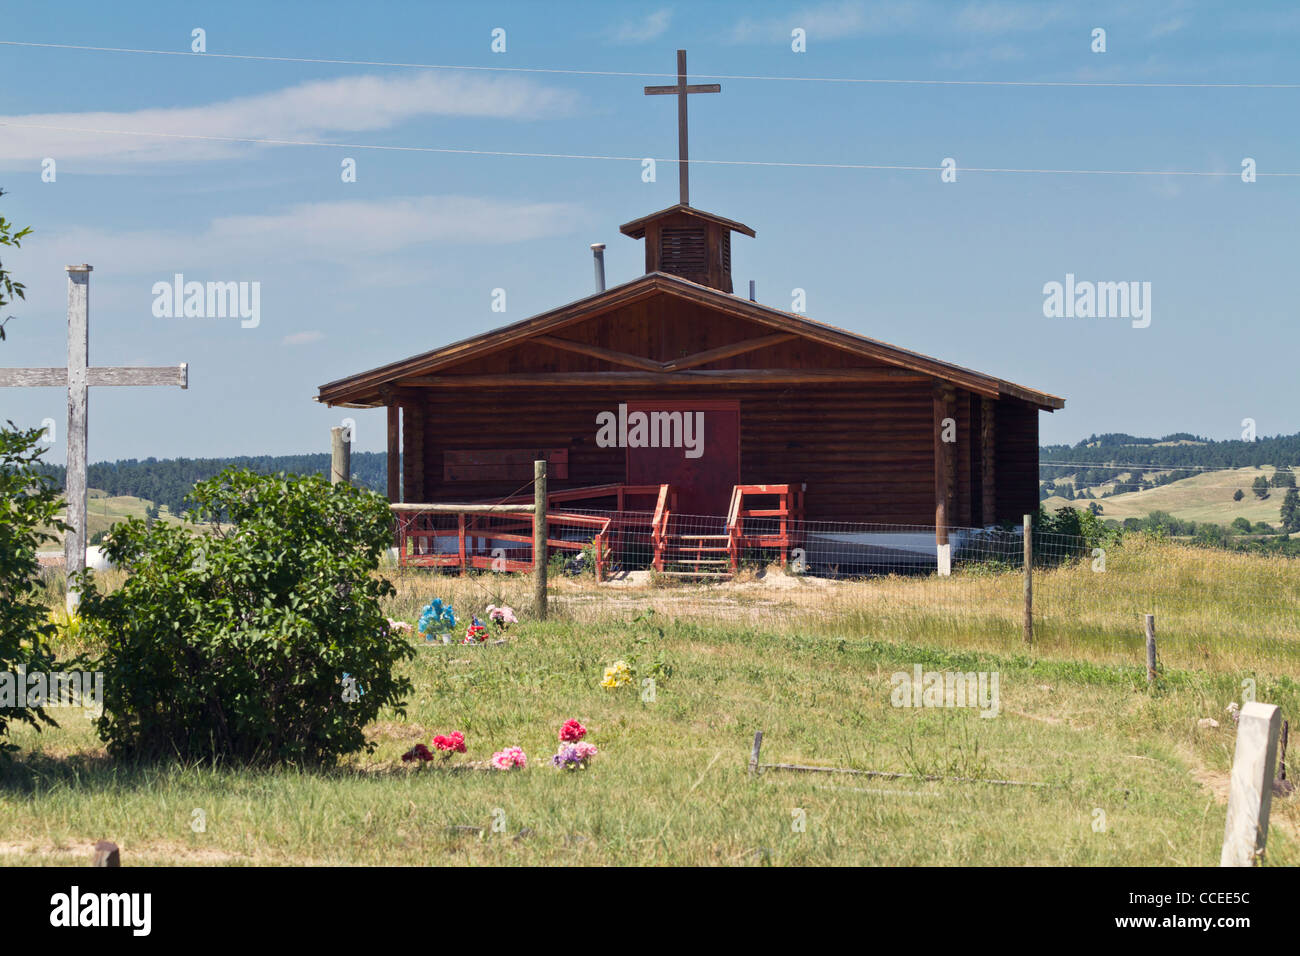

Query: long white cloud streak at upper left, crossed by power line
<box><xmin>0</xmin><ymin>72</ymin><xmax>576</xmax><ymax>165</ymax></box>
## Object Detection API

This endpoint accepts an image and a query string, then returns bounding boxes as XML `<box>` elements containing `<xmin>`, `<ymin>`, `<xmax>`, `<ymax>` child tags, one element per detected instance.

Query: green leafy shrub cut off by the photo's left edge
<box><xmin>0</xmin><ymin>421</ymin><xmax>68</xmax><ymax>750</ymax></box>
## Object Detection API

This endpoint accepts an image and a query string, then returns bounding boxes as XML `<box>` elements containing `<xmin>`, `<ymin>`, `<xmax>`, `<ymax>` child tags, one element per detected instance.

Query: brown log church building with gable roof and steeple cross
<box><xmin>317</xmin><ymin>57</ymin><xmax>1065</xmax><ymax>572</ymax></box>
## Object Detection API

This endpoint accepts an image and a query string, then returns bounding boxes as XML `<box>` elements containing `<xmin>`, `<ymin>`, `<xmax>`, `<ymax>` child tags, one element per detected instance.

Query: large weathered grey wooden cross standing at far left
<box><xmin>0</xmin><ymin>265</ymin><xmax>190</xmax><ymax>611</ymax></box>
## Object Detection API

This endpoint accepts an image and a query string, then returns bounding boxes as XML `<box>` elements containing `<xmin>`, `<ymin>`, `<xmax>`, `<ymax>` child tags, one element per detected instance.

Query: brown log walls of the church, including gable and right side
<box><xmin>384</xmin><ymin>295</ymin><xmax>1039</xmax><ymax>527</ymax></box>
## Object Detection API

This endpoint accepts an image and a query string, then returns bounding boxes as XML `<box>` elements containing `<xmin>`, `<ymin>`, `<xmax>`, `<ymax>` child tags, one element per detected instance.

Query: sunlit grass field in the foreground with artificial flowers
<box><xmin>0</xmin><ymin>537</ymin><xmax>1300</xmax><ymax>865</ymax></box>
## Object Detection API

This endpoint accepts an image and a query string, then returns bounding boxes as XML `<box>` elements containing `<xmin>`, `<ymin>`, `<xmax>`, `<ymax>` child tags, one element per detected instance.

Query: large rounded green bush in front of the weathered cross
<box><xmin>81</xmin><ymin>470</ymin><xmax>415</xmax><ymax>763</ymax></box>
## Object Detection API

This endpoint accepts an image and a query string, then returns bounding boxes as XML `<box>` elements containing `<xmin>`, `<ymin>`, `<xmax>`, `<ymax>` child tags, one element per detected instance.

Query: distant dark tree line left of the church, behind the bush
<box><xmin>32</xmin><ymin>451</ymin><xmax>389</xmax><ymax>516</ymax></box>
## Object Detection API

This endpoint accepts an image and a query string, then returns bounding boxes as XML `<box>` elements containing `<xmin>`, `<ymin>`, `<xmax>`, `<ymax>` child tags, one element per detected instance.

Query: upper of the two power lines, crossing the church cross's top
<box><xmin>0</xmin><ymin>40</ymin><xmax>1300</xmax><ymax>90</ymax></box>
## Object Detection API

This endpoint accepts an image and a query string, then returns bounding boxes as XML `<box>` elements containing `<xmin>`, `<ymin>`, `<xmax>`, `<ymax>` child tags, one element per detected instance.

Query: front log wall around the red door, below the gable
<box><xmin>404</xmin><ymin>382</ymin><xmax>946</xmax><ymax>524</ymax></box>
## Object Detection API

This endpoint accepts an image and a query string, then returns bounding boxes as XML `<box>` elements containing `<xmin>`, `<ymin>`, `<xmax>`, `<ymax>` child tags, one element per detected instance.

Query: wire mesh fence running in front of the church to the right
<box><xmin>387</xmin><ymin>509</ymin><xmax>1300</xmax><ymax>676</ymax></box>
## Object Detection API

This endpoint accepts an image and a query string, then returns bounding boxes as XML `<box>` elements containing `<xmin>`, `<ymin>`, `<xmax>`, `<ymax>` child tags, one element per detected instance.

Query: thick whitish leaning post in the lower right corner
<box><xmin>1219</xmin><ymin>701</ymin><xmax>1282</xmax><ymax>866</ymax></box>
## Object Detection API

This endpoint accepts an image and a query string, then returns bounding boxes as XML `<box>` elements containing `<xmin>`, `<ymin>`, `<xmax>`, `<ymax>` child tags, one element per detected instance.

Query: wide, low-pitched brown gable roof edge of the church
<box><xmin>316</xmin><ymin>273</ymin><xmax>1065</xmax><ymax>411</ymax></box>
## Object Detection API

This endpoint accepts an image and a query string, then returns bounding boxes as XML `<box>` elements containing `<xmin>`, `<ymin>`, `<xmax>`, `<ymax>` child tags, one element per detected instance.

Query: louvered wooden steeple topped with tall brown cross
<box><xmin>619</xmin><ymin>49</ymin><xmax>754</xmax><ymax>293</ymax></box>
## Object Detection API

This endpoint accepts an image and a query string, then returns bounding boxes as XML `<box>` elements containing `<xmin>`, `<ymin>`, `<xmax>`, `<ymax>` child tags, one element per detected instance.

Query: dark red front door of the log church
<box><xmin>627</xmin><ymin>402</ymin><xmax>740</xmax><ymax>516</ymax></box>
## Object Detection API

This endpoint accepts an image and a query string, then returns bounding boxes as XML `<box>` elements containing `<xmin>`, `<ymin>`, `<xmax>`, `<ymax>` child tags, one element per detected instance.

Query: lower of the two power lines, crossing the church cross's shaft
<box><xmin>0</xmin><ymin>121</ymin><xmax>1300</xmax><ymax>178</ymax></box>
